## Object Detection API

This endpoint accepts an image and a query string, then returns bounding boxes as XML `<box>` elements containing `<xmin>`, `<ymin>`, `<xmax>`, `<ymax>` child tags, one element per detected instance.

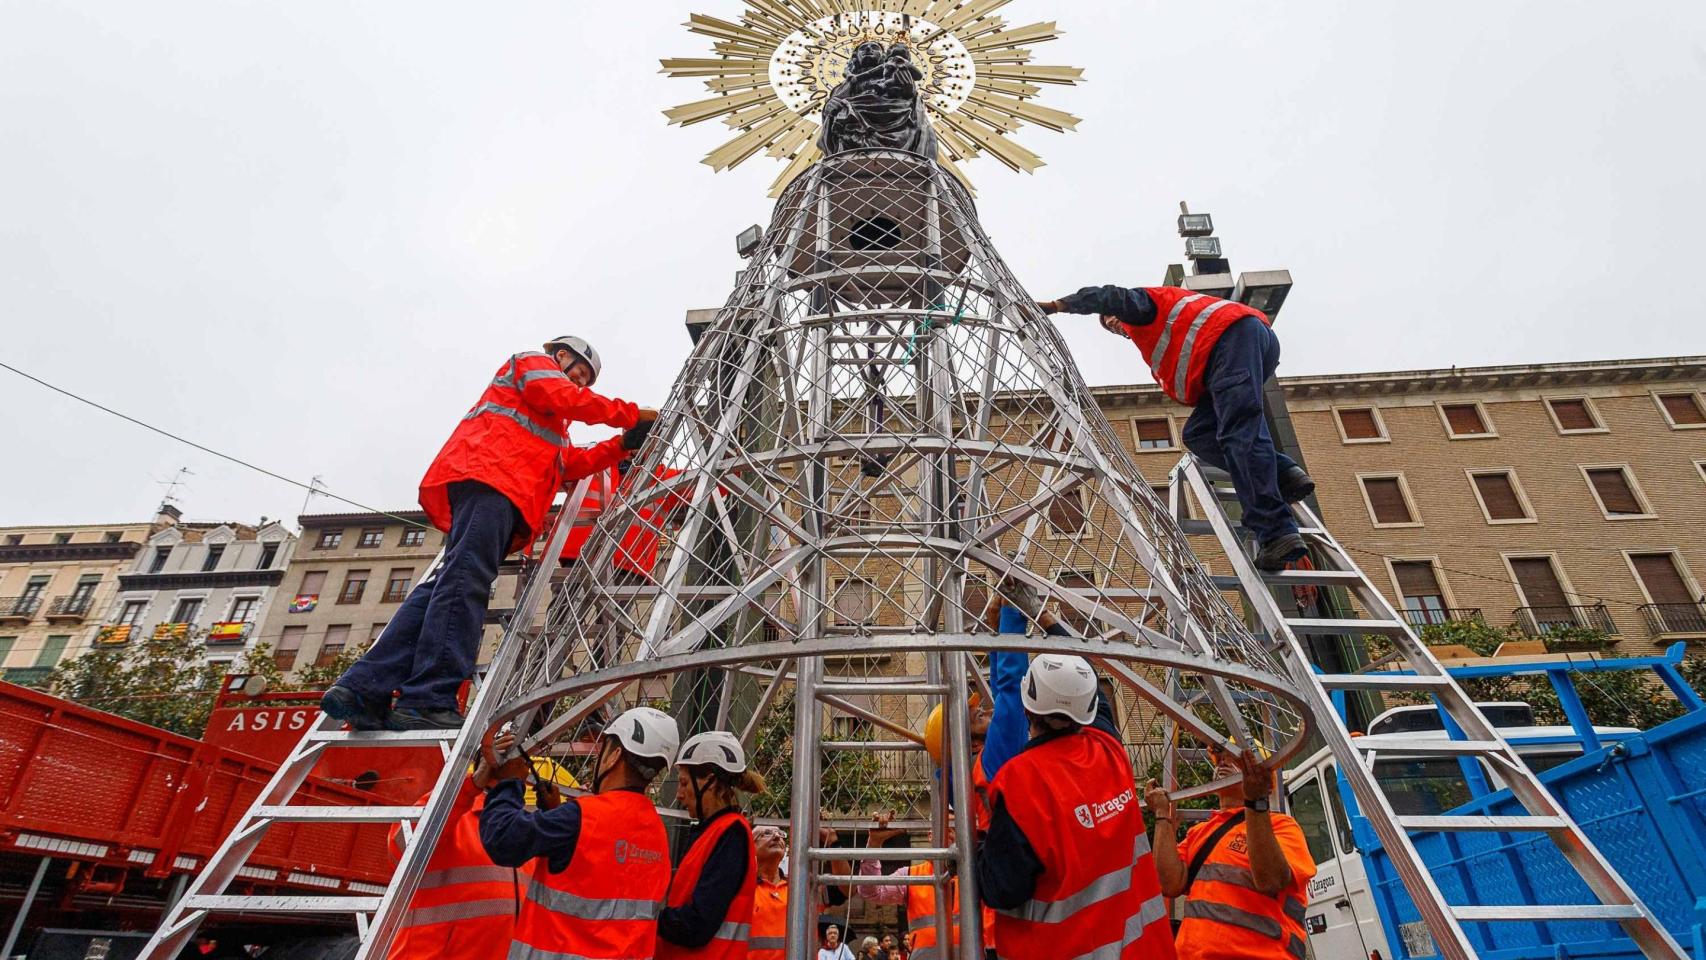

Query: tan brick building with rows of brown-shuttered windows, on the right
<box><xmin>1095</xmin><ymin>356</ymin><xmax>1706</xmax><ymax>653</ymax></box>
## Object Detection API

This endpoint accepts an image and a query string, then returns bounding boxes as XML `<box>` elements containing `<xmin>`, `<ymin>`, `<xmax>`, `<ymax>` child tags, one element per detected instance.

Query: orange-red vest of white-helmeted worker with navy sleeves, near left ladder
<box><xmin>508</xmin><ymin>789</ymin><xmax>669</xmax><ymax>960</ymax></box>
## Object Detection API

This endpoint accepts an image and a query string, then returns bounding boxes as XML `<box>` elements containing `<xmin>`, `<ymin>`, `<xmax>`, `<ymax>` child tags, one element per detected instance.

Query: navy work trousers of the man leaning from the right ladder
<box><xmin>1184</xmin><ymin>317</ymin><xmax>1297</xmax><ymax>544</ymax></box>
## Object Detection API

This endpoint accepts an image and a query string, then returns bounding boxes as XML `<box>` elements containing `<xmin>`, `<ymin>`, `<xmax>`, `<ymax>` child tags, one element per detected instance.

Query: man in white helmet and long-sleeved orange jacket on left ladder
<box><xmin>321</xmin><ymin>336</ymin><xmax>657</xmax><ymax>730</ymax></box>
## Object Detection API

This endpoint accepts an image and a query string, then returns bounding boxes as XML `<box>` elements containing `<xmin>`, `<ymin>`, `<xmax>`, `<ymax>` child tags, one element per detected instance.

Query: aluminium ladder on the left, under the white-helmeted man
<box><xmin>140</xmin><ymin>477</ymin><xmax>607</xmax><ymax>960</ymax></box>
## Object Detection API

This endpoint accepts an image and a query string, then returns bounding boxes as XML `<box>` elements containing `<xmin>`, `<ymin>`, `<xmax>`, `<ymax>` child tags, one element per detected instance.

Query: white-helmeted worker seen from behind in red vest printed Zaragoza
<box><xmin>978</xmin><ymin>653</ymin><xmax>1174</xmax><ymax>960</ymax></box>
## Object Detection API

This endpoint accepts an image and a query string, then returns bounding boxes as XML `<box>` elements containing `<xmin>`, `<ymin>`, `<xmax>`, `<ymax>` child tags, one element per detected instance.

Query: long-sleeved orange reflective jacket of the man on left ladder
<box><xmin>420</xmin><ymin>353</ymin><xmax>640</xmax><ymax>551</ymax></box>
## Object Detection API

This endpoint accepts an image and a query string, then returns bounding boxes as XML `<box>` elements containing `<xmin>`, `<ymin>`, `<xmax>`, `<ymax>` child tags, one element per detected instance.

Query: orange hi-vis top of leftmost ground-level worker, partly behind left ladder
<box><xmin>386</xmin><ymin>779</ymin><xmax>527</xmax><ymax>960</ymax></box>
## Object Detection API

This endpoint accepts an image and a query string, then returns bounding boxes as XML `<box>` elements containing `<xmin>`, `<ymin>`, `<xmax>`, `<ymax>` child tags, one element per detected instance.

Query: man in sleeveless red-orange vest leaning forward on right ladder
<box><xmin>1037</xmin><ymin>286</ymin><xmax>1315</xmax><ymax>570</ymax></box>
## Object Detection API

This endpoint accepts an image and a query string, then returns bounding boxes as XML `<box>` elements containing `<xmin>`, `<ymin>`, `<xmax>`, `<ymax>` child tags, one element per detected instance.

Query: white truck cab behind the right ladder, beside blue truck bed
<box><xmin>1285</xmin><ymin>703</ymin><xmax>1639</xmax><ymax>960</ymax></box>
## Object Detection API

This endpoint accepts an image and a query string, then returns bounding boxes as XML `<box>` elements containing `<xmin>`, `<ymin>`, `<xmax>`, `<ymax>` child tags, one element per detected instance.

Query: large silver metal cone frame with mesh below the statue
<box><xmin>495</xmin><ymin>150</ymin><xmax>1309</xmax><ymax>957</ymax></box>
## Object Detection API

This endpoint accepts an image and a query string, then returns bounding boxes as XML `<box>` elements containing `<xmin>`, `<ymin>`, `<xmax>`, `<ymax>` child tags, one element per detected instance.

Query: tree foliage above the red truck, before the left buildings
<box><xmin>44</xmin><ymin>636</ymin><xmax>365</xmax><ymax>737</ymax></box>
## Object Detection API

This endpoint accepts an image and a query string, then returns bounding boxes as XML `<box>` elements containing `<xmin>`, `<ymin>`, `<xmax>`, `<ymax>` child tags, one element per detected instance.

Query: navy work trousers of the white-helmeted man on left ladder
<box><xmin>338</xmin><ymin>481</ymin><xmax>522</xmax><ymax>709</ymax></box>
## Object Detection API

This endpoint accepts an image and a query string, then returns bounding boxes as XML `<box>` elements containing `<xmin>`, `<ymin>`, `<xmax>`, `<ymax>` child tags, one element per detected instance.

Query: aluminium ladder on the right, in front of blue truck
<box><xmin>1169</xmin><ymin>455</ymin><xmax>1687</xmax><ymax>960</ymax></box>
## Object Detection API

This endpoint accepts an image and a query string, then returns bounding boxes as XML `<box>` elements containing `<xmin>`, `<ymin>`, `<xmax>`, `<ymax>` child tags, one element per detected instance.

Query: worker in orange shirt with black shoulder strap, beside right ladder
<box><xmin>1145</xmin><ymin>745</ymin><xmax>1315</xmax><ymax>960</ymax></box>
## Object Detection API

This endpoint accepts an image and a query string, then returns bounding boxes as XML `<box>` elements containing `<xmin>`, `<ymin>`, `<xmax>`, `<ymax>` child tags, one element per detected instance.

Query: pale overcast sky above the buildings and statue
<box><xmin>0</xmin><ymin>0</ymin><xmax>1706</xmax><ymax>523</ymax></box>
